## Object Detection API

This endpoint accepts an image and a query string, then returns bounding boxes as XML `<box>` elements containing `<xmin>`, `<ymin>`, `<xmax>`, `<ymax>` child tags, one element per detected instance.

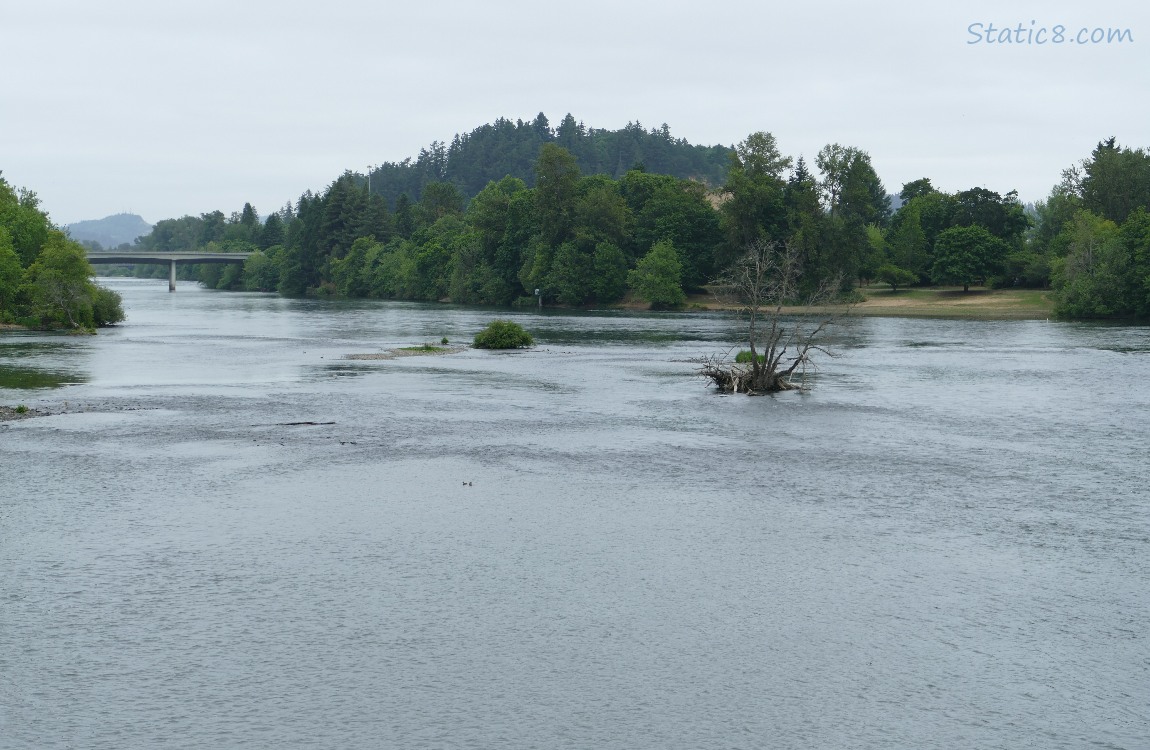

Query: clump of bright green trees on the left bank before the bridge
<box><xmin>0</xmin><ymin>175</ymin><xmax>124</xmax><ymax>330</ymax></box>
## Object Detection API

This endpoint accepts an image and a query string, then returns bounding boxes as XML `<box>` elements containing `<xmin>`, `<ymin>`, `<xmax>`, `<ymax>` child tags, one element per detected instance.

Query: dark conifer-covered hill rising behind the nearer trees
<box><xmin>371</xmin><ymin>112</ymin><xmax>733</xmax><ymax>208</ymax></box>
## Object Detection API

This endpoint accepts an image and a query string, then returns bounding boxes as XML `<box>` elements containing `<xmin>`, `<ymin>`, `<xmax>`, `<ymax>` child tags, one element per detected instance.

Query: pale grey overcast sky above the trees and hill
<box><xmin>0</xmin><ymin>0</ymin><xmax>1150</xmax><ymax>224</ymax></box>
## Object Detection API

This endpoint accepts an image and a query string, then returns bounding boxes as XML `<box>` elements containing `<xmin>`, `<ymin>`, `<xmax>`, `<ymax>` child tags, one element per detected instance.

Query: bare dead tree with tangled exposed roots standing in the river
<box><xmin>698</xmin><ymin>240</ymin><xmax>848</xmax><ymax>395</ymax></box>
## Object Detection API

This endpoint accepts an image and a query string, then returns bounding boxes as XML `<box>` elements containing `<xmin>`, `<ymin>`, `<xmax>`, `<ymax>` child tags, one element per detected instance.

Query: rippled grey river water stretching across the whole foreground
<box><xmin>0</xmin><ymin>280</ymin><xmax>1150</xmax><ymax>750</ymax></box>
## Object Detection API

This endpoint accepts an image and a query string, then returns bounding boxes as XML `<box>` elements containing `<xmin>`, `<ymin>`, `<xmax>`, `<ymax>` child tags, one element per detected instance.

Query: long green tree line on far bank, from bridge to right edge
<box><xmin>130</xmin><ymin>120</ymin><xmax>1150</xmax><ymax>316</ymax></box>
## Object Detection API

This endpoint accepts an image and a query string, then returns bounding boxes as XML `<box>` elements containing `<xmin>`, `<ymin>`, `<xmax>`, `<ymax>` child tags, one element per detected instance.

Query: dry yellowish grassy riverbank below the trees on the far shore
<box><xmin>688</xmin><ymin>286</ymin><xmax>1055</xmax><ymax>320</ymax></box>
